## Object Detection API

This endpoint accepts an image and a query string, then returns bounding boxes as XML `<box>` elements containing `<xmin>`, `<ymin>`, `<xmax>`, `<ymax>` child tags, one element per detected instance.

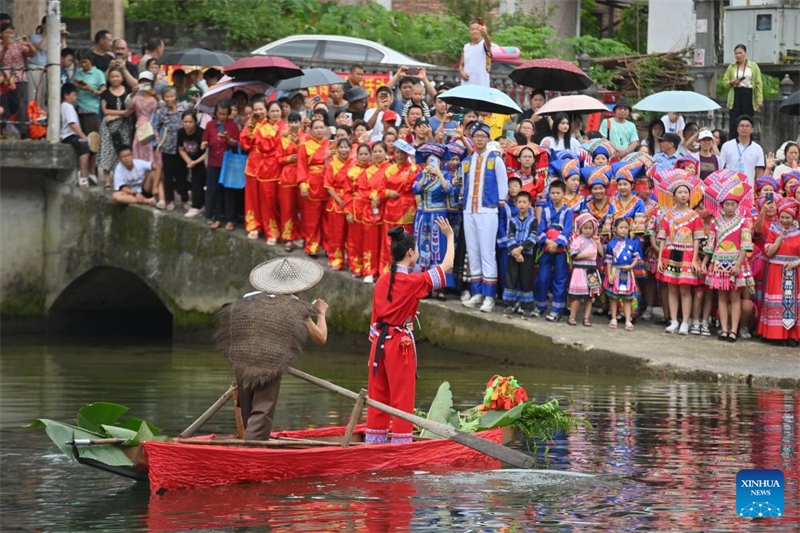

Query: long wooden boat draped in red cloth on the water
<box><xmin>75</xmin><ymin>425</ymin><xmax>513</xmax><ymax>491</ymax></box>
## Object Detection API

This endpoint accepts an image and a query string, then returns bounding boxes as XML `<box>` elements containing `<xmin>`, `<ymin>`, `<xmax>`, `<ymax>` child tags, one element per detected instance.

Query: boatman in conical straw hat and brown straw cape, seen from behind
<box><xmin>216</xmin><ymin>257</ymin><xmax>328</xmax><ymax>440</ymax></box>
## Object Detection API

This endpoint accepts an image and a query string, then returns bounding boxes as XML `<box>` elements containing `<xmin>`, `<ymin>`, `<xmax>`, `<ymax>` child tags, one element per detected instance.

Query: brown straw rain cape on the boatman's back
<box><xmin>219</xmin><ymin>293</ymin><xmax>317</xmax><ymax>387</ymax></box>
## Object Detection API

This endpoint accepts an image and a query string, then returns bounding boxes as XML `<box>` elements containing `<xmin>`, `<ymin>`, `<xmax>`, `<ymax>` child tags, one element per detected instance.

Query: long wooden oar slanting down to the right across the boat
<box><xmin>288</xmin><ymin>367</ymin><xmax>533</xmax><ymax>468</ymax></box>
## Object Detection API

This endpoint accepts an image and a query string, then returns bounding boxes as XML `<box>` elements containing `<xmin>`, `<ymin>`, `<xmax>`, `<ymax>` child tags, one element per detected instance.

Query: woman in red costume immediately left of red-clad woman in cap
<box><xmin>356</xmin><ymin>142</ymin><xmax>392</xmax><ymax>283</ymax></box>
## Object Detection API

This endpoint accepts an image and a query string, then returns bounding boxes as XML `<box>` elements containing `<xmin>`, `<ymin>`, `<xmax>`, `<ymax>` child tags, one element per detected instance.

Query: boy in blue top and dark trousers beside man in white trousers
<box><xmin>503</xmin><ymin>191</ymin><xmax>536</xmax><ymax>318</ymax></box>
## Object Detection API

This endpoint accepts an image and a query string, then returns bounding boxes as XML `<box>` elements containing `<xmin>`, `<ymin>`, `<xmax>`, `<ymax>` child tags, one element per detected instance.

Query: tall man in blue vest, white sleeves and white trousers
<box><xmin>461</xmin><ymin>122</ymin><xmax>508</xmax><ymax>313</ymax></box>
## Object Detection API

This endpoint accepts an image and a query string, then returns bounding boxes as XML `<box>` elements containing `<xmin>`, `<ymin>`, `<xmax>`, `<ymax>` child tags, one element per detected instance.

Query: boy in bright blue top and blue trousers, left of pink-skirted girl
<box><xmin>533</xmin><ymin>181</ymin><xmax>573</xmax><ymax>322</ymax></box>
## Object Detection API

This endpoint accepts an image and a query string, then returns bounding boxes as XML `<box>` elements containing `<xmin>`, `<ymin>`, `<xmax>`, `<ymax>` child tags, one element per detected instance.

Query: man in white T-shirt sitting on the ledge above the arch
<box><xmin>111</xmin><ymin>145</ymin><xmax>165</xmax><ymax>209</ymax></box>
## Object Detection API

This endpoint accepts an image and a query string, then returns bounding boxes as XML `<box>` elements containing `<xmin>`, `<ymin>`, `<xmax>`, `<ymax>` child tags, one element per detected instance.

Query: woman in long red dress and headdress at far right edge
<box><xmin>758</xmin><ymin>198</ymin><xmax>800</xmax><ymax>347</ymax></box>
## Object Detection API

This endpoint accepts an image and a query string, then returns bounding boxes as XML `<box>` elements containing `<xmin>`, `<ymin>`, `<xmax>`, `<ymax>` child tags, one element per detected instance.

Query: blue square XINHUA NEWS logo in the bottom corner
<box><xmin>736</xmin><ymin>470</ymin><xmax>784</xmax><ymax>518</ymax></box>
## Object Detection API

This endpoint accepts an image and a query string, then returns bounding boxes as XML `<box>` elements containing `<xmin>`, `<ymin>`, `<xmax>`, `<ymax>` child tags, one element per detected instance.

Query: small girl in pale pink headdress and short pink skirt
<box><xmin>567</xmin><ymin>213</ymin><xmax>603</xmax><ymax>328</ymax></box>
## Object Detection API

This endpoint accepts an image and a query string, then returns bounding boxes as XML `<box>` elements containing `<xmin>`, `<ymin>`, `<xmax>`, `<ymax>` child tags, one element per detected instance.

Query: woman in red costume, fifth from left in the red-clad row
<box><xmin>325</xmin><ymin>139</ymin><xmax>354</xmax><ymax>270</ymax></box>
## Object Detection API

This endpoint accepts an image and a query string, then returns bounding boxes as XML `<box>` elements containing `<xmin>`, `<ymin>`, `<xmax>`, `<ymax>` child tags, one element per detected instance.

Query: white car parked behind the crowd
<box><xmin>251</xmin><ymin>35</ymin><xmax>434</xmax><ymax>67</ymax></box>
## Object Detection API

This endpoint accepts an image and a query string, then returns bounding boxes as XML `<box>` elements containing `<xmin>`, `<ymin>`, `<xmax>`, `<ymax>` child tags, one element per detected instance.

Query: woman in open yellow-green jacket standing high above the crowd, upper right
<box><xmin>723</xmin><ymin>44</ymin><xmax>764</xmax><ymax>139</ymax></box>
